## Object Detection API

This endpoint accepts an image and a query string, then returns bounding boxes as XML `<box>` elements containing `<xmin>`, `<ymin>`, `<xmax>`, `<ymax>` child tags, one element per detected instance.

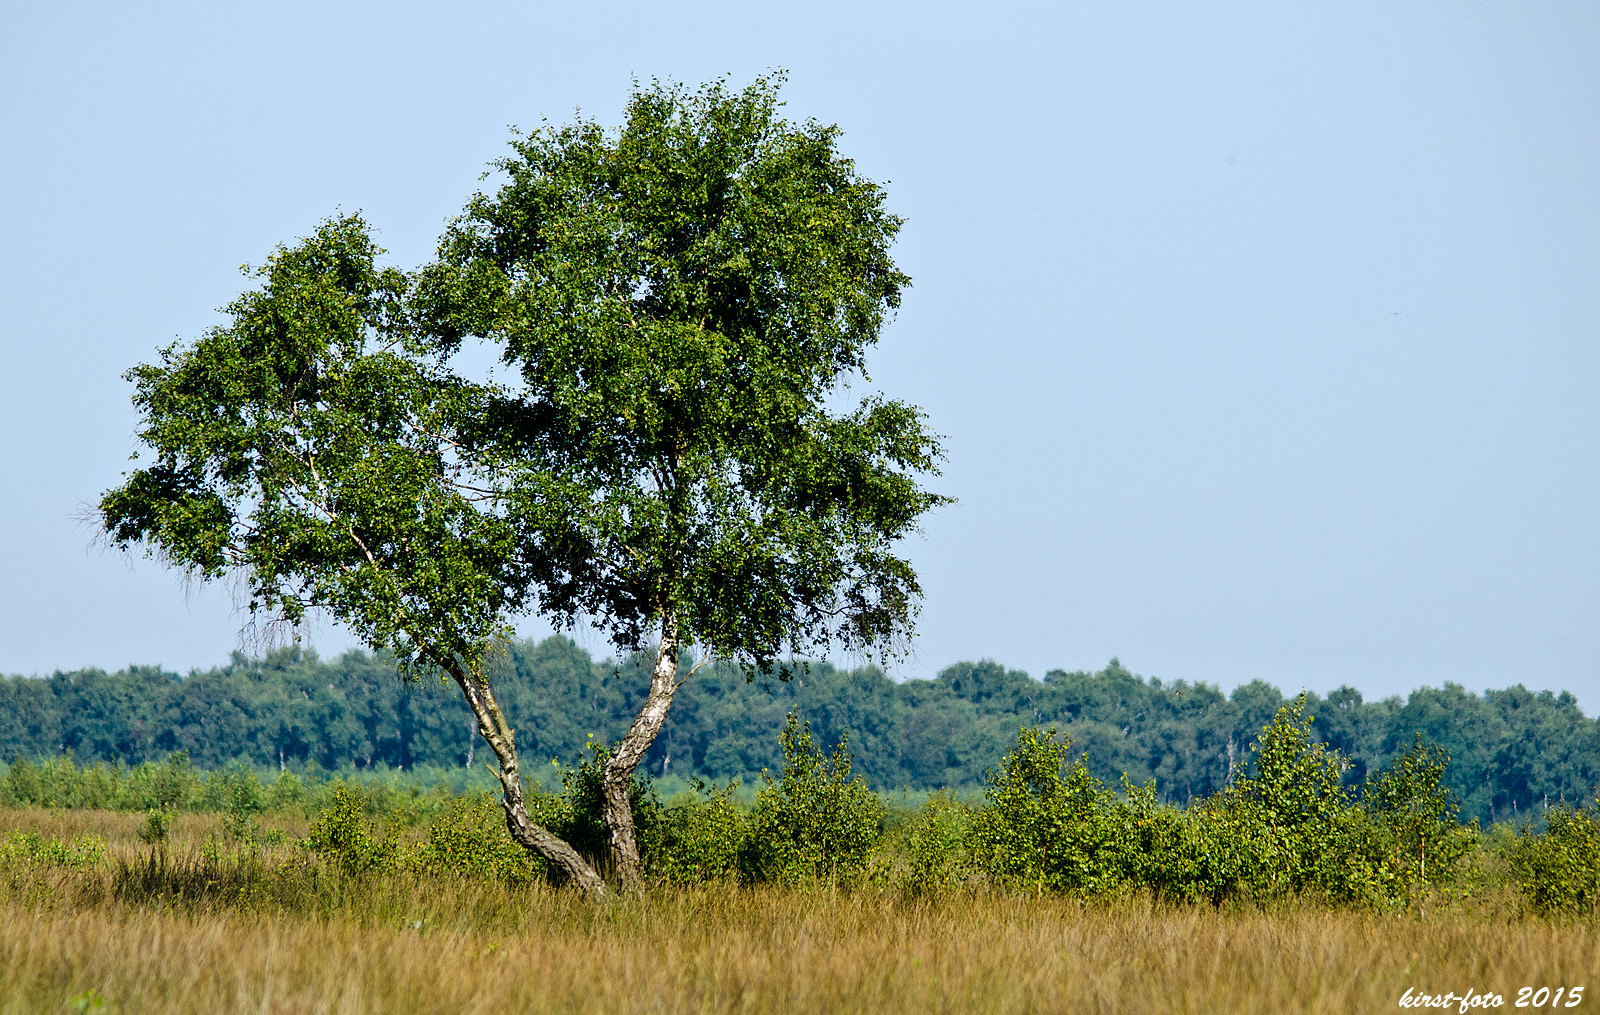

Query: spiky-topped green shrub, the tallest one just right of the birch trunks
<box><xmin>739</xmin><ymin>712</ymin><xmax>886</xmax><ymax>884</ymax></box>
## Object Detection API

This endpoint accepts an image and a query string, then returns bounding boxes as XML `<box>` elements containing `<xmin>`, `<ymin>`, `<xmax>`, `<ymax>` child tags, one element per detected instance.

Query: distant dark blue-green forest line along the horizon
<box><xmin>0</xmin><ymin>636</ymin><xmax>1600</xmax><ymax>821</ymax></box>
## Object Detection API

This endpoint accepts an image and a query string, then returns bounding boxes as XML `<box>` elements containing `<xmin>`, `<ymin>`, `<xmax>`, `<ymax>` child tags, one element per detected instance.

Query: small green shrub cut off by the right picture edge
<box><xmin>1507</xmin><ymin>800</ymin><xmax>1600</xmax><ymax>919</ymax></box>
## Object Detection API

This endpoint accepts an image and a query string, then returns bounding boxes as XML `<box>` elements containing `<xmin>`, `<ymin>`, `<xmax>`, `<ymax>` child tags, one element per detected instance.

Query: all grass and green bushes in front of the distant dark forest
<box><xmin>0</xmin><ymin>696</ymin><xmax>1600</xmax><ymax>1013</ymax></box>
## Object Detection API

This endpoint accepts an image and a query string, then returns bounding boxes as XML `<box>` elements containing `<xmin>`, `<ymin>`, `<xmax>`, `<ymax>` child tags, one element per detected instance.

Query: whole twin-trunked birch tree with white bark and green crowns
<box><xmin>101</xmin><ymin>73</ymin><xmax>946</xmax><ymax>893</ymax></box>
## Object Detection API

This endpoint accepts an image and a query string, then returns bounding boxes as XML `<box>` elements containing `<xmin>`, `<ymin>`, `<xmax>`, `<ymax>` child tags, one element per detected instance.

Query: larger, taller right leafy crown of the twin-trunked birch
<box><xmin>418</xmin><ymin>78</ymin><xmax>944</xmax><ymax>668</ymax></box>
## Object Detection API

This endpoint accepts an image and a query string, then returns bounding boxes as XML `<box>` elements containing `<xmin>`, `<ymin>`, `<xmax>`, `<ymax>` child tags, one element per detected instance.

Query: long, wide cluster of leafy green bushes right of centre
<box><xmin>947</xmin><ymin>701</ymin><xmax>1477</xmax><ymax>903</ymax></box>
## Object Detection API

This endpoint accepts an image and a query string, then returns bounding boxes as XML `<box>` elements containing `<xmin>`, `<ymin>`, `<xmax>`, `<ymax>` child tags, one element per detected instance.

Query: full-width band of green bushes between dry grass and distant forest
<box><xmin>0</xmin><ymin>698</ymin><xmax>1529</xmax><ymax>916</ymax></box>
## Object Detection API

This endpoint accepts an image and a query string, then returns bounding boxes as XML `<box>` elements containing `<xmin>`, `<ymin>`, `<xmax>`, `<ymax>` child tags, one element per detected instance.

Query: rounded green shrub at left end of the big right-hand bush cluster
<box><xmin>968</xmin><ymin>727</ymin><xmax>1126</xmax><ymax>895</ymax></box>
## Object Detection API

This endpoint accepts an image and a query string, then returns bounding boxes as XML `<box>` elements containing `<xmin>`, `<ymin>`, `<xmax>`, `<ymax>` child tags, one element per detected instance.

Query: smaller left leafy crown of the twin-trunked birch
<box><xmin>101</xmin><ymin>216</ymin><xmax>515</xmax><ymax>666</ymax></box>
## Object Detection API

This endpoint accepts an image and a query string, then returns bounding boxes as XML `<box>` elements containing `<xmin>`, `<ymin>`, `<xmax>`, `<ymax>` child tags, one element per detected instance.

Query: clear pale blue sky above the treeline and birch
<box><xmin>0</xmin><ymin>2</ymin><xmax>1600</xmax><ymax>714</ymax></box>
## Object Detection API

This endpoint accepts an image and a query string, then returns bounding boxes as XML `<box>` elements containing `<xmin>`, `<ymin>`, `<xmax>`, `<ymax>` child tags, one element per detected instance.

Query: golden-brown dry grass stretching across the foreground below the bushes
<box><xmin>0</xmin><ymin>812</ymin><xmax>1600</xmax><ymax>1015</ymax></box>
